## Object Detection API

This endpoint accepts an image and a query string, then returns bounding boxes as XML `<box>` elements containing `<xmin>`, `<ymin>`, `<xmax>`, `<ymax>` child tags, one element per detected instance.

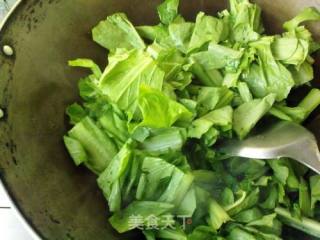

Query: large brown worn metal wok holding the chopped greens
<box><xmin>0</xmin><ymin>0</ymin><xmax>320</xmax><ymax>240</ymax></box>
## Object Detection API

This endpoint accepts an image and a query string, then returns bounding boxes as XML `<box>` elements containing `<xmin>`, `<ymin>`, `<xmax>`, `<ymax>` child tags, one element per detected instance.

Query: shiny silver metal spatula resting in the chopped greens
<box><xmin>219</xmin><ymin>122</ymin><xmax>320</xmax><ymax>174</ymax></box>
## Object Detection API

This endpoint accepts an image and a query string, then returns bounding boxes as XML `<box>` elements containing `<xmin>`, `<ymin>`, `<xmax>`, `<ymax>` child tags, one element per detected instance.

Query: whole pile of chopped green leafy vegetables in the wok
<box><xmin>64</xmin><ymin>0</ymin><xmax>320</xmax><ymax>240</ymax></box>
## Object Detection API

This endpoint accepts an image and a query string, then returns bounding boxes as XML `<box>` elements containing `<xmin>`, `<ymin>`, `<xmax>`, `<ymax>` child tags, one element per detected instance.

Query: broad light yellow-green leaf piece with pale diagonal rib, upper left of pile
<box><xmin>99</xmin><ymin>50</ymin><xmax>164</xmax><ymax>115</ymax></box>
